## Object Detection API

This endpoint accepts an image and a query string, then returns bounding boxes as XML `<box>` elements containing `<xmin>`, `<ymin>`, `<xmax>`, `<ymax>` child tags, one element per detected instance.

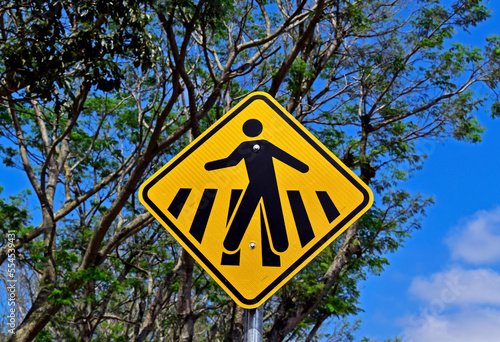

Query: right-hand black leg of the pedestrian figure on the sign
<box><xmin>263</xmin><ymin>187</ymin><xmax>288</xmax><ymax>252</ymax></box>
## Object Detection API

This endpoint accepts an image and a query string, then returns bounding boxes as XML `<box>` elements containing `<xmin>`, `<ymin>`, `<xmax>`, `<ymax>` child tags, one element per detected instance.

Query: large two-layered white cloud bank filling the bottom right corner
<box><xmin>400</xmin><ymin>267</ymin><xmax>500</xmax><ymax>342</ymax></box>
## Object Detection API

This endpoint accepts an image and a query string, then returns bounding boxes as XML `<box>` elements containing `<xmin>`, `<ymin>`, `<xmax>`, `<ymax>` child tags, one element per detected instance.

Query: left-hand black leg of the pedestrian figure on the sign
<box><xmin>224</xmin><ymin>186</ymin><xmax>260</xmax><ymax>252</ymax></box>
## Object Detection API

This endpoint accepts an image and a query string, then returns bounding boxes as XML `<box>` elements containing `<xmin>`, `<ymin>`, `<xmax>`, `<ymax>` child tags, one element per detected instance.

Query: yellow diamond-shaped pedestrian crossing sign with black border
<box><xmin>139</xmin><ymin>92</ymin><xmax>373</xmax><ymax>309</ymax></box>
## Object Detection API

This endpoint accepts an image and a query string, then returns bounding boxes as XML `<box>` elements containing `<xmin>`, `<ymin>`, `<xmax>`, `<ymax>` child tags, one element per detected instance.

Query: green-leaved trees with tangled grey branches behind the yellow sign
<box><xmin>0</xmin><ymin>0</ymin><xmax>500</xmax><ymax>341</ymax></box>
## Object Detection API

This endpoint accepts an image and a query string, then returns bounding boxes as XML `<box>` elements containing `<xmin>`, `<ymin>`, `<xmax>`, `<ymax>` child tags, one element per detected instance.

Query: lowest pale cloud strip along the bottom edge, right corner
<box><xmin>403</xmin><ymin>308</ymin><xmax>500</xmax><ymax>342</ymax></box>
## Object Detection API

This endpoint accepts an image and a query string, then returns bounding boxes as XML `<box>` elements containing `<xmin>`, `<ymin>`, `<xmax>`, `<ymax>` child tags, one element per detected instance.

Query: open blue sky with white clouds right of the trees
<box><xmin>356</xmin><ymin>1</ymin><xmax>500</xmax><ymax>342</ymax></box>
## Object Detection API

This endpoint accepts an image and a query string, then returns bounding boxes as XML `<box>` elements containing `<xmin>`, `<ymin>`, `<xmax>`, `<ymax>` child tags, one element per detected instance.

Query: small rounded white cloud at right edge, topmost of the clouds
<box><xmin>446</xmin><ymin>207</ymin><xmax>500</xmax><ymax>264</ymax></box>
